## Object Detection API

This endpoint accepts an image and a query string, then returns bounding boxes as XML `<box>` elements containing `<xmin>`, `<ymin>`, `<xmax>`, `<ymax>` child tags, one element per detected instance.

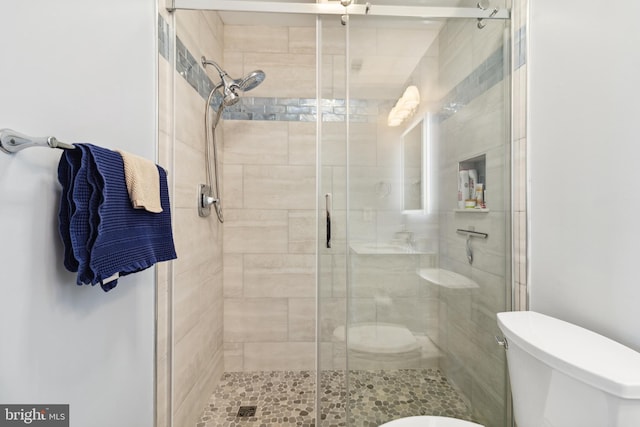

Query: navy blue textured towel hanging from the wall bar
<box><xmin>58</xmin><ymin>144</ymin><xmax>176</xmax><ymax>291</ymax></box>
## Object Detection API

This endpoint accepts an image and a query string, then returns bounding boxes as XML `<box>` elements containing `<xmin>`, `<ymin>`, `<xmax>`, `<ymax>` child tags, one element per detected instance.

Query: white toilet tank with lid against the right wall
<box><xmin>498</xmin><ymin>311</ymin><xmax>640</xmax><ymax>427</ymax></box>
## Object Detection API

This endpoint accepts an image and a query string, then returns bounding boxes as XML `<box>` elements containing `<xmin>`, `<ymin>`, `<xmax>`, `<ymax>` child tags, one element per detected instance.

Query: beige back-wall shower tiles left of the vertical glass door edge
<box><xmin>223</xmin><ymin>25</ymin><xmax>316</xmax><ymax>371</ymax></box>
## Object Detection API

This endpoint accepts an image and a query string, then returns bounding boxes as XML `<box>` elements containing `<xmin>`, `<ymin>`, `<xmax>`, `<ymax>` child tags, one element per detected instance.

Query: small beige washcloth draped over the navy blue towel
<box><xmin>116</xmin><ymin>150</ymin><xmax>162</xmax><ymax>213</ymax></box>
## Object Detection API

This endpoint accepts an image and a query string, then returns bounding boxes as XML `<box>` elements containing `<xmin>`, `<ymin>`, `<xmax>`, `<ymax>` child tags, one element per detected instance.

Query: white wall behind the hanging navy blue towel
<box><xmin>0</xmin><ymin>0</ymin><xmax>157</xmax><ymax>427</ymax></box>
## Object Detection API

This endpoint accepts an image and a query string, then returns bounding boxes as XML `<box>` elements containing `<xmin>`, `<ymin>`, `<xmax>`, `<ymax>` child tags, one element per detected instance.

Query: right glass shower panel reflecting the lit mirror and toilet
<box><xmin>344</xmin><ymin>16</ymin><xmax>511</xmax><ymax>426</ymax></box>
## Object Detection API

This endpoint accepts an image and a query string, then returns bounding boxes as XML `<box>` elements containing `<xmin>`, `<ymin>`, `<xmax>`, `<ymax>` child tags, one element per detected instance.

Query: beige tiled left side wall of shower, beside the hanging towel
<box><xmin>156</xmin><ymin>2</ymin><xmax>224</xmax><ymax>427</ymax></box>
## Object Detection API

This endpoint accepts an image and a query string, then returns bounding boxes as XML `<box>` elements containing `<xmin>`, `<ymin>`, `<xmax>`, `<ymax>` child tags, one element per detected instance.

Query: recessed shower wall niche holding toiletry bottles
<box><xmin>455</xmin><ymin>154</ymin><xmax>490</xmax><ymax>212</ymax></box>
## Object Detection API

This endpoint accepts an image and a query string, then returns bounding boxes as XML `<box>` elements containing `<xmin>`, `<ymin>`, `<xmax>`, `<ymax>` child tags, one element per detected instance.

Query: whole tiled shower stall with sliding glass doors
<box><xmin>157</xmin><ymin>0</ymin><xmax>514</xmax><ymax>427</ymax></box>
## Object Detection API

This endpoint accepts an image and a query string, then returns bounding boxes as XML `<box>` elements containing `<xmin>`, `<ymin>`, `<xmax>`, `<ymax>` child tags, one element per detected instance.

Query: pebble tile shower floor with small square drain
<box><xmin>196</xmin><ymin>369</ymin><xmax>473</xmax><ymax>427</ymax></box>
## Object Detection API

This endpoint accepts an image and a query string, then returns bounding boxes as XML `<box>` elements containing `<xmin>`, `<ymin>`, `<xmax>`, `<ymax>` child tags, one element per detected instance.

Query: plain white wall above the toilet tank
<box><xmin>527</xmin><ymin>0</ymin><xmax>640</xmax><ymax>350</ymax></box>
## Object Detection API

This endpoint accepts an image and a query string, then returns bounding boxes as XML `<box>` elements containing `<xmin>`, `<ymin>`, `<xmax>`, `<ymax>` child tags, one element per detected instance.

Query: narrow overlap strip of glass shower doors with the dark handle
<box><xmin>317</xmin><ymin>16</ymin><xmax>348</xmax><ymax>426</ymax></box>
